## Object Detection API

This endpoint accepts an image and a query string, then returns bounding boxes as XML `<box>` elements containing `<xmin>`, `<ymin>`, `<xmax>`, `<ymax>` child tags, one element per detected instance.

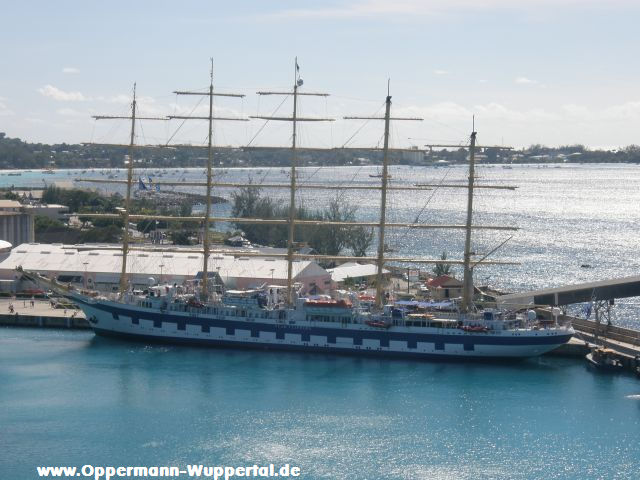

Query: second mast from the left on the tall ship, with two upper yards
<box><xmin>168</xmin><ymin>58</ymin><xmax>249</xmax><ymax>300</ymax></box>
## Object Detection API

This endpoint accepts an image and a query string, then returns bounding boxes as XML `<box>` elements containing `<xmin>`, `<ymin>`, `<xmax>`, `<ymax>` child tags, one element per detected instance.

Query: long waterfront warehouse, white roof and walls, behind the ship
<box><xmin>0</xmin><ymin>243</ymin><xmax>331</xmax><ymax>294</ymax></box>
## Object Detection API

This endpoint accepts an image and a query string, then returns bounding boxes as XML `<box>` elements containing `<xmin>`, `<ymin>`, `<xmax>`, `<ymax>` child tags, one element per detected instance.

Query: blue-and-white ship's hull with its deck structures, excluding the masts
<box><xmin>58</xmin><ymin>286</ymin><xmax>574</xmax><ymax>359</ymax></box>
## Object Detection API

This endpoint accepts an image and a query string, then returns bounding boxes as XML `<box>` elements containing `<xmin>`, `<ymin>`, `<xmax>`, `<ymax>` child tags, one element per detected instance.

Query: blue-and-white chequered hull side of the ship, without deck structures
<box><xmin>75</xmin><ymin>297</ymin><xmax>573</xmax><ymax>360</ymax></box>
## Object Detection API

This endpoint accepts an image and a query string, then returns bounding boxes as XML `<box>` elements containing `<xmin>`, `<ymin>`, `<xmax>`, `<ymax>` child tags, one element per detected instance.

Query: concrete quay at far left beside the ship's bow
<box><xmin>0</xmin><ymin>298</ymin><xmax>90</xmax><ymax>329</ymax></box>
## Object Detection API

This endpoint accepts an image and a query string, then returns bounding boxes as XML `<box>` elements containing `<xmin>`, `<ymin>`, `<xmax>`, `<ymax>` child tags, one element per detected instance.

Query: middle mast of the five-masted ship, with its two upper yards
<box><xmin>250</xmin><ymin>57</ymin><xmax>333</xmax><ymax>305</ymax></box>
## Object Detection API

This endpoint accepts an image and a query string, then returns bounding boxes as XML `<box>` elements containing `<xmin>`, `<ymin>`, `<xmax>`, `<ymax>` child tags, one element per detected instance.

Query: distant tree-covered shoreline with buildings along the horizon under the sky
<box><xmin>0</xmin><ymin>132</ymin><xmax>640</xmax><ymax>171</ymax></box>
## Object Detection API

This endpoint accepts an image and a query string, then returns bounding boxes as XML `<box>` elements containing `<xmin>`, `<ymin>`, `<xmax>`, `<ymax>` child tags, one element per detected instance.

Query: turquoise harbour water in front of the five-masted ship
<box><xmin>0</xmin><ymin>328</ymin><xmax>640</xmax><ymax>480</ymax></box>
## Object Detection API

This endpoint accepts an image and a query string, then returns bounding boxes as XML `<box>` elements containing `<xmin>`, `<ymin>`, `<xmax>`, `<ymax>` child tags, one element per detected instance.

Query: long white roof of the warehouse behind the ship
<box><xmin>0</xmin><ymin>243</ymin><xmax>326</xmax><ymax>280</ymax></box>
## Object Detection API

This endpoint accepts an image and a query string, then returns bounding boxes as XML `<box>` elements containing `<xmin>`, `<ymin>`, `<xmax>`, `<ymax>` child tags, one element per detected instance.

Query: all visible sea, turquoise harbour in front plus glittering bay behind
<box><xmin>0</xmin><ymin>164</ymin><xmax>640</xmax><ymax>480</ymax></box>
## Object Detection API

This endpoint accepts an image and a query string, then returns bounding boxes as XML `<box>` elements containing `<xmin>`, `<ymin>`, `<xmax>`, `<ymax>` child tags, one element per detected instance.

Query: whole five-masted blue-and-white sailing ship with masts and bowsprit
<box><xmin>30</xmin><ymin>61</ymin><xmax>574</xmax><ymax>359</ymax></box>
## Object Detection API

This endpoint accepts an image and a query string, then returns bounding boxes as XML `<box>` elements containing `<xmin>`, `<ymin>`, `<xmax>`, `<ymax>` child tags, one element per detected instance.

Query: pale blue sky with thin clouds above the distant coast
<box><xmin>0</xmin><ymin>0</ymin><xmax>640</xmax><ymax>148</ymax></box>
